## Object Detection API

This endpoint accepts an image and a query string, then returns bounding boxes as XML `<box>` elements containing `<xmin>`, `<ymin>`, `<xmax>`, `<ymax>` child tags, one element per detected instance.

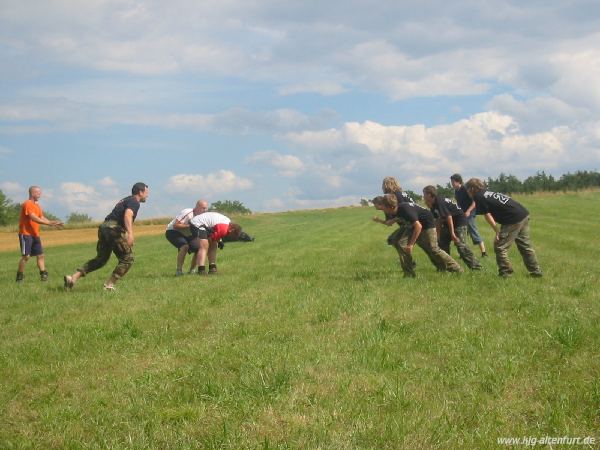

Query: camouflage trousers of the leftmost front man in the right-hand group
<box><xmin>396</xmin><ymin>227</ymin><xmax>463</xmax><ymax>277</ymax></box>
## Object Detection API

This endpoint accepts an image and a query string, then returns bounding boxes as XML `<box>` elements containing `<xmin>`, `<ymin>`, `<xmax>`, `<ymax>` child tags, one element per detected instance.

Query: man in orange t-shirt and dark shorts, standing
<box><xmin>17</xmin><ymin>186</ymin><xmax>63</xmax><ymax>283</ymax></box>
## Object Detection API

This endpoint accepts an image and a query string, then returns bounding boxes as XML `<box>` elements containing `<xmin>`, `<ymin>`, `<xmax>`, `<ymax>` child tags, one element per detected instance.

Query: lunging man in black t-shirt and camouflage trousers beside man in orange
<box><xmin>64</xmin><ymin>183</ymin><xmax>150</xmax><ymax>291</ymax></box>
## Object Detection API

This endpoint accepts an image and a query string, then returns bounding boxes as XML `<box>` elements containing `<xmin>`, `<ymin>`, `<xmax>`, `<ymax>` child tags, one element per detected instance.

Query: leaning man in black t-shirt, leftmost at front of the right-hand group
<box><xmin>373</xmin><ymin>194</ymin><xmax>463</xmax><ymax>277</ymax></box>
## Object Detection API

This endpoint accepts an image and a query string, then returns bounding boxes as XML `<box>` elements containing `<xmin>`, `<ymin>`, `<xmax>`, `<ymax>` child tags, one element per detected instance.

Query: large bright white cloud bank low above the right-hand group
<box><xmin>286</xmin><ymin>112</ymin><xmax>599</xmax><ymax>188</ymax></box>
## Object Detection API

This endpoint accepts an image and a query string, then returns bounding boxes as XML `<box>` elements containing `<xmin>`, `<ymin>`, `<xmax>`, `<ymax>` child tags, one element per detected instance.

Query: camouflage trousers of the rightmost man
<box><xmin>494</xmin><ymin>216</ymin><xmax>542</xmax><ymax>276</ymax></box>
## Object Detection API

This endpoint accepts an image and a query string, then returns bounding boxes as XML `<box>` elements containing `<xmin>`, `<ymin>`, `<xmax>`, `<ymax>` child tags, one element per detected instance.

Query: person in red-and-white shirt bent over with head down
<box><xmin>190</xmin><ymin>212</ymin><xmax>242</xmax><ymax>275</ymax></box>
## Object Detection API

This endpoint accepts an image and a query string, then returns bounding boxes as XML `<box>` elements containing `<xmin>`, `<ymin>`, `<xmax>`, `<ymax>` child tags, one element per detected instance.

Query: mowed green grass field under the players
<box><xmin>0</xmin><ymin>192</ymin><xmax>600</xmax><ymax>449</ymax></box>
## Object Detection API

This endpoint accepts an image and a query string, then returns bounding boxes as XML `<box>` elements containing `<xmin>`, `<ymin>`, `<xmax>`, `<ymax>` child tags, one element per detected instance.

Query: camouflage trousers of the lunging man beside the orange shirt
<box><xmin>77</xmin><ymin>222</ymin><xmax>133</xmax><ymax>279</ymax></box>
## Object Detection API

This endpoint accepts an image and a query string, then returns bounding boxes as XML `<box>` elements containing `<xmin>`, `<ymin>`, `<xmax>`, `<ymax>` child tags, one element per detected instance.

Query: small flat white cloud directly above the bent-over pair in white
<box><xmin>166</xmin><ymin>170</ymin><xmax>253</xmax><ymax>196</ymax></box>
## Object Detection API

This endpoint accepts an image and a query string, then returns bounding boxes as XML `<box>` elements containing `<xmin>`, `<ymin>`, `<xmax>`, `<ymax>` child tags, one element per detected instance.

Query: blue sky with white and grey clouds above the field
<box><xmin>0</xmin><ymin>0</ymin><xmax>600</xmax><ymax>219</ymax></box>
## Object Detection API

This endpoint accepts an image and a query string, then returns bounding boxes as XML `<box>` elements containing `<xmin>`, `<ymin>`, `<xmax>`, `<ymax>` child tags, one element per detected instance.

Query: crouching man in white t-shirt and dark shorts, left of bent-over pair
<box><xmin>165</xmin><ymin>200</ymin><xmax>208</xmax><ymax>277</ymax></box>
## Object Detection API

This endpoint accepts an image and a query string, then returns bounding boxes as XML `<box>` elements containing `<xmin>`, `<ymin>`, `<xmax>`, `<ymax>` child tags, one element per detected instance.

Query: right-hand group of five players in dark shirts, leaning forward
<box><xmin>372</xmin><ymin>174</ymin><xmax>542</xmax><ymax>278</ymax></box>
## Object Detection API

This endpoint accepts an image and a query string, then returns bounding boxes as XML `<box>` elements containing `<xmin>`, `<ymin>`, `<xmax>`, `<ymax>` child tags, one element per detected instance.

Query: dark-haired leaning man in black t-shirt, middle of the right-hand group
<box><xmin>423</xmin><ymin>186</ymin><xmax>481</xmax><ymax>270</ymax></box>
